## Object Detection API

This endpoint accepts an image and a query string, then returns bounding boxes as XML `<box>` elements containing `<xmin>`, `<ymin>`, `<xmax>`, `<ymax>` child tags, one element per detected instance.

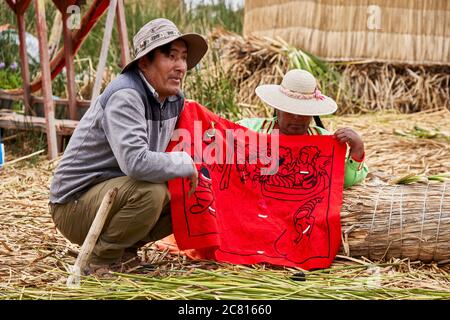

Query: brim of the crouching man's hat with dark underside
<box><xmin>121</xmin><ymin>33</ymin><xmax>208</xmax><ymax>73</ymax></box>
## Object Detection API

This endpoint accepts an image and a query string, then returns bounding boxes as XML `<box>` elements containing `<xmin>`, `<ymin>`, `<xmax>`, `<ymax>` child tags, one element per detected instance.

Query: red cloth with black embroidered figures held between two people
<box><xmin>168</xmin><ymin>100</ymin><xmax>346</xmax><ymax>270</ymax></box>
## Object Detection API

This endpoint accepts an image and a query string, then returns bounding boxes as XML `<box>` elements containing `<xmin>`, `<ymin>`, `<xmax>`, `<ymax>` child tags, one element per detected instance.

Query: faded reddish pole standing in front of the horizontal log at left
<box><xmin>33</xmin><ymin>0</ymin><xmax>58</xmax><ymax>160</ymax></box>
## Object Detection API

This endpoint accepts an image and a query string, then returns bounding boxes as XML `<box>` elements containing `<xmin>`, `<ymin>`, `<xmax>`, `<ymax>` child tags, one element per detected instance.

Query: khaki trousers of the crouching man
<box><xmin>50</xmin><ymin>177</ymin><xmax>172</xmax><ymax>264</ymax></box>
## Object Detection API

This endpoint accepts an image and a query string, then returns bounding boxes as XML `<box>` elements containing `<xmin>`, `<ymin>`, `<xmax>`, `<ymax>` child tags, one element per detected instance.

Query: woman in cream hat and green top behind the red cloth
<box><xmin>237</xmin><ymin>69</ymin><xmax>369</xmax><ymax>188</ymax></box>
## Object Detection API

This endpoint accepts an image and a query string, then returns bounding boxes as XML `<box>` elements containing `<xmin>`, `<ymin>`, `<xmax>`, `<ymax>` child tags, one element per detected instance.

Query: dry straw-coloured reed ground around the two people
<box><xmin>0</xmin><ymin>110</ymin><xmax>450</xmax><ymax>299</ymax></box>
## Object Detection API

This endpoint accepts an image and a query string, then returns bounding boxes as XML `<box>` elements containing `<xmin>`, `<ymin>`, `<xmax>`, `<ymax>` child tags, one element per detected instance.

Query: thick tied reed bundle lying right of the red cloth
<box><xmin>341</xmin><ymin>181</ymin><xmax>450</xmax><ymax>262</ymax></box>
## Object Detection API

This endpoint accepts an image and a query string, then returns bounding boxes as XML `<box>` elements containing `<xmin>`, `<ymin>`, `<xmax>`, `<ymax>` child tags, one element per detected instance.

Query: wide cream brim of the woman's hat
<box><xmin>255</xmin><ymin>84</ymin><xmax>337</xmax><ymax>116</ymax></box>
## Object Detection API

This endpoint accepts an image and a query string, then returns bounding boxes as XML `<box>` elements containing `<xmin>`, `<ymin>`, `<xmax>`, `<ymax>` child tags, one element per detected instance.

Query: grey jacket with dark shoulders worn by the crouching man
<box><xmin>50</xmin><ymin>68</ymin><xmax>194</xmax><ymax>203</ymax></box>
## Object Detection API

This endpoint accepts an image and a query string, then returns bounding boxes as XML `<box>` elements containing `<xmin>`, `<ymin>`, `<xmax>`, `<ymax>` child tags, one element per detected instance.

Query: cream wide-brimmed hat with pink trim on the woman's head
<box><xmin>255</xmin><ymin>69</ymin><xmax>337</xmax><ymax>116</ymax></box>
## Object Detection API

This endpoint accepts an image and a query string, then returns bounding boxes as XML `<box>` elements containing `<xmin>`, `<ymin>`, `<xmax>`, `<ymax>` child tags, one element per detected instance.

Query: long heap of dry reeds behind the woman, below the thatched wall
<box><xmin>212</xmin><ymin>29</ymin><xmax>450</xmax><ymax>116</ymax></box>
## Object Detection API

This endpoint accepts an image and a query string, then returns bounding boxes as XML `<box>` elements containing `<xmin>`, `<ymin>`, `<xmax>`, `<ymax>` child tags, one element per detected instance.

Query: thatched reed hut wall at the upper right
<box><xmin>244</xmin><ymin>0</ymin><xmax>450</xmax><ymax>65</ymax></box>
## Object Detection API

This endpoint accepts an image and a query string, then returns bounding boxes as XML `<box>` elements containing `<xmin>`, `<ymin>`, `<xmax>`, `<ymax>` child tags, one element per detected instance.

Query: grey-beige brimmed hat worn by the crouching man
<box><xmin>122</xmin><ymin>18</ymin><xmax>208</xmax><ymax>73</ymax></box>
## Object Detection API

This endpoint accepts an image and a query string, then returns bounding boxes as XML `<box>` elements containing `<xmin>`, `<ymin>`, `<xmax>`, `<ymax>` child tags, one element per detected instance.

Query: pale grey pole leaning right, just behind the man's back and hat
<box><xmin>91</xmin><ymin>0</ymin><xmax>117</xmax><ymax>107</ymax></box>
